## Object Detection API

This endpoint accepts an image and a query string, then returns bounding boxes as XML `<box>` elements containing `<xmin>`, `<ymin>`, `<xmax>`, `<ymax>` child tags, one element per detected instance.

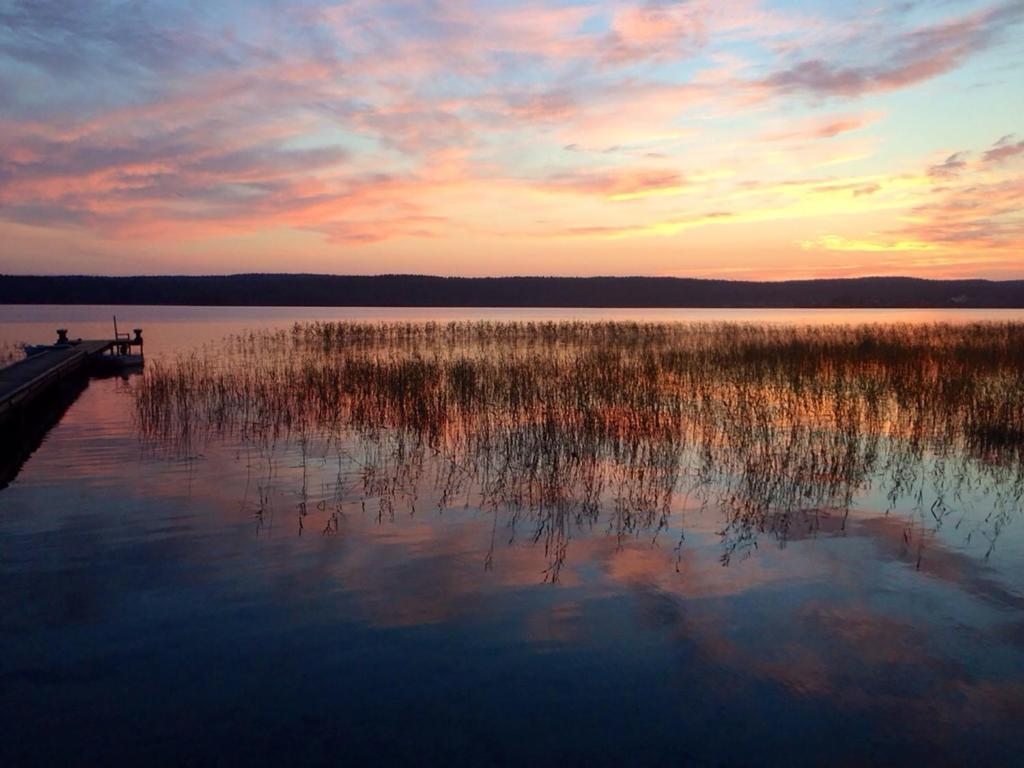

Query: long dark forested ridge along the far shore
<box><xmin>0</xmin><ymin>274</ymin><xmax>1024</xmax><ymax>308</ymax></box>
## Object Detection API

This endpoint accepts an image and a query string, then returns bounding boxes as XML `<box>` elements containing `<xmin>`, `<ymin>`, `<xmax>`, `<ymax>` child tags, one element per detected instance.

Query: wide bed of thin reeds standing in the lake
<box><xmin>134</xmin><ymin>323</ymin><xmax>1024</xmax><ymax>573</ymax></box>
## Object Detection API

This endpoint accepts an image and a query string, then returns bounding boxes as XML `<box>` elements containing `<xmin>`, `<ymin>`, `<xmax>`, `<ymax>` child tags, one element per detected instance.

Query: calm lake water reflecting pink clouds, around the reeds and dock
<box><xmin>0</xmin><ymin>306</ymin><xmax>1024</xmax><ymax>765</ymax></box>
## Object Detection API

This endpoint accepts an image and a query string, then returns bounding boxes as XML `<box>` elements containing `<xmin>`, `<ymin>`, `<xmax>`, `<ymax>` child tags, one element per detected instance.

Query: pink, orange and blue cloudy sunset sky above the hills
<box><xmin>0</xmin><ymin>0</ymin><xmax>1024</xmax><ymax>280</ymax></box>
